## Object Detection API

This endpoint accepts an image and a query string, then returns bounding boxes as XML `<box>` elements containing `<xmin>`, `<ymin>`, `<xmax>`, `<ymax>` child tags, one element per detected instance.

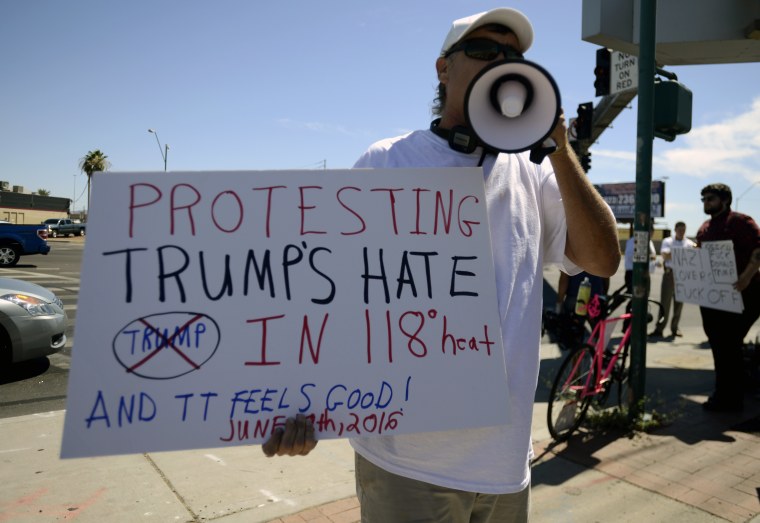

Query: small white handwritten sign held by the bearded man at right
<box><xmin>671</xmin><ymin>240</ymin><xmax>744</xmax><ymax>313</ymax></box>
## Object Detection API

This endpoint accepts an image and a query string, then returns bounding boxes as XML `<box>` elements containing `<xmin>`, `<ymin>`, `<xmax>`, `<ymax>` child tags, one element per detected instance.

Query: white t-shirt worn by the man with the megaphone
<box><xmin>351</xmin><ymin>130</ymin><xmax>579</xmax><ymax>494</ymax></box>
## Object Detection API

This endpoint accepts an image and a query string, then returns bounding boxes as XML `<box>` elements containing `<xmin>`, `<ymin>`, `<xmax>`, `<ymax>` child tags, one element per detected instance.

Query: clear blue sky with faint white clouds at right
<box><xmin>0</xmin><ymin>0</ymin><xmax>760</xmax><ymax>234</ymax></box>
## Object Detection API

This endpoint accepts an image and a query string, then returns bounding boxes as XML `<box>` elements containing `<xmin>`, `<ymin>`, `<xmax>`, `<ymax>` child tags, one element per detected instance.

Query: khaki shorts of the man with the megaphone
<box><xmin>355</xmin><ymin>454</ymin><xmax>530</xmax><ymax>523</ymax></box>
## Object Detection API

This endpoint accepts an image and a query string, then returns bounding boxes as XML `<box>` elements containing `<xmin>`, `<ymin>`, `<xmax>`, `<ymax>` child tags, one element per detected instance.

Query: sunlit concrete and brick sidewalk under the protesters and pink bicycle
<box><xmin>0</xmin><ymin>268</ymin><xmax>760</xmax><ymax>523</ymax></box>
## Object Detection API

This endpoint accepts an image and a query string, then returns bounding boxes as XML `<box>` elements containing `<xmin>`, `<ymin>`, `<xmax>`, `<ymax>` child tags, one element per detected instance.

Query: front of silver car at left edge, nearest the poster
<box><xmin>0</xmin><ymin>278</ymin><xmax>68</xmax><ymax>369</ymax></box>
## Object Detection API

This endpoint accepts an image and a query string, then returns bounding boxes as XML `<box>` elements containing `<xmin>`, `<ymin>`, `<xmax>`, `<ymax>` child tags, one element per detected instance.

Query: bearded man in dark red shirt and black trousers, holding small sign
<box><xmin>697</xmin><ymin>183</ymin><xmax>760</xmax><ymax>412</ymax></box>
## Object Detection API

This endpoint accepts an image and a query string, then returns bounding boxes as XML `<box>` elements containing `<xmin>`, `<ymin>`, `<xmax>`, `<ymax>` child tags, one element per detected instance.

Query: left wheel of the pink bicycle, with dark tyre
<box><xmin>546</xmin><ymin>345</ymin><xmax>594</xmax><ymax>441</ymax></box>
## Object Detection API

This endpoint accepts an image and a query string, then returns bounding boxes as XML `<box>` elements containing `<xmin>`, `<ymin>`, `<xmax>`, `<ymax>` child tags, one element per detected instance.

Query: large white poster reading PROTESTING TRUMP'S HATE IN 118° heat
<box><xmin>61</xmin><ymin>169</ymin><xmax>509</xmax><ymax>457</ymax></box>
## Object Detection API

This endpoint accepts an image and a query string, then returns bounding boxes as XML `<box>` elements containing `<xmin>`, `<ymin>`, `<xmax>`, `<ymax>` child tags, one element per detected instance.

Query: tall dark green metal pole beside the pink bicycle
<box><xmin>628</xmin><ymin>0</ymin><xmax>657</xmax><ymax>420</ymax></box>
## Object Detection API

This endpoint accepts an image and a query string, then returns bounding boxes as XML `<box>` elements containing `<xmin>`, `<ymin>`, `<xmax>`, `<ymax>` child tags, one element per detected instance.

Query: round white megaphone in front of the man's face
<box><xmin>464</xmin><ymin>59</ymin><xmax>562</xmax><ymax>163</ymax></box>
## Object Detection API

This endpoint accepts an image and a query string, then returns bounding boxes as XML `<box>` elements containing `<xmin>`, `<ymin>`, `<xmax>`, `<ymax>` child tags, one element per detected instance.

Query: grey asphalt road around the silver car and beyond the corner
<box><xmin>0</xmin><ymin>237</ymin><xmax>701</xmax><ymax>418</ymax></box>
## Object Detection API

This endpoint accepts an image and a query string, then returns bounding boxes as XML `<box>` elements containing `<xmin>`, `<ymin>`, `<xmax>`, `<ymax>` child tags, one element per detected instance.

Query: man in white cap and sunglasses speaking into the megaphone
<box><xmin>263</xmin><ymin>8</ymin><xmax>620</xmax><ymax>523</ymax></box>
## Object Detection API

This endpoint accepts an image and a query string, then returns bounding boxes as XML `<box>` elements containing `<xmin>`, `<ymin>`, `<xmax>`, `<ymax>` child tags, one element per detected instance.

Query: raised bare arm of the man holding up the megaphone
<box><xmin>549</xmin><ymin>115</ymin><xmax>620</xmax><ymax>277</ymax></box>
